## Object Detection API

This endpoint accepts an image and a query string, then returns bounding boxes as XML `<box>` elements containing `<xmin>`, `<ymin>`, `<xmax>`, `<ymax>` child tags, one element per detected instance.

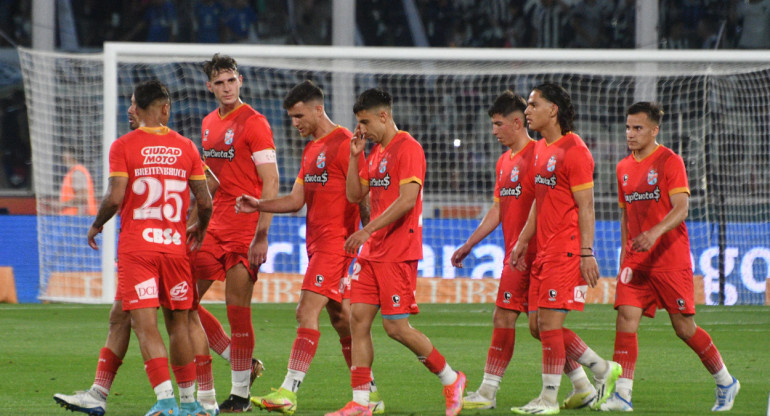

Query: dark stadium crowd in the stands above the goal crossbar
<box><xmin>0</xmin><ymin>0</ymin><xmax>770</xmax><ymax>49</ymax></box>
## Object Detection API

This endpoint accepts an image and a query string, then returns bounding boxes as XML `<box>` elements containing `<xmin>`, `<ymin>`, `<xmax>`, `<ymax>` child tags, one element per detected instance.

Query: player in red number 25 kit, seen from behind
<box><xmin>88</xmin><ymin>81</ymin><xmax>212</xmax><ymax>415</ymax></box>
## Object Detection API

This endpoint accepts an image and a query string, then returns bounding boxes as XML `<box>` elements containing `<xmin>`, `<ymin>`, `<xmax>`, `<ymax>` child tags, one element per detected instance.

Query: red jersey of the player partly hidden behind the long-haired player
<box><xmin>495</xmin><ymin>141</ymin><xmax>537</xmax><ymax>264</ymax></box>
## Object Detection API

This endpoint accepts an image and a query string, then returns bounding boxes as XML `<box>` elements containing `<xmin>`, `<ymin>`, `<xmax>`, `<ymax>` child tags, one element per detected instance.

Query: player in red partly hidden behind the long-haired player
<box><xmin>452</xmin><ymin>90</ymin><xmax>537</xmax><ymax>409</ymax></box>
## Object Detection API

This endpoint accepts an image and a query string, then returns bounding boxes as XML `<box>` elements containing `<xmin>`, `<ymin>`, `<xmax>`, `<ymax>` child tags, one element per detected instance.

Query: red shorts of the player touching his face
<box><xmin>350</xmin><ymin>258</ymin><xmax>420</xmax><ymax>315</ymax></box>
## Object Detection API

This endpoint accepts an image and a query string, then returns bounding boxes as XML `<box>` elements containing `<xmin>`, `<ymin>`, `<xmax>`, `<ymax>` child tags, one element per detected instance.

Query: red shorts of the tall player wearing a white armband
<box><xmin>190</xmin><ymin>229</ymin><xmax>257</xmax><ymax>282</ymax></box>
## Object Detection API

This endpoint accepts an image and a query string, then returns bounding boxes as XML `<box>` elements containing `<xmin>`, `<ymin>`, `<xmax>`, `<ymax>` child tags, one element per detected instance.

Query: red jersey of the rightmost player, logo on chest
<box><xmin>617</xmin><ymin>145</ymin><xmax>692</xmax><ymax>271</ymax></box>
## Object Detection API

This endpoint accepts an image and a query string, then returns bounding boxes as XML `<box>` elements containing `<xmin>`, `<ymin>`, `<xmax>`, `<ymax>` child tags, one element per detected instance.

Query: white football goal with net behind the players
<box><xmin>19</xmin><ymin>43</ymin><xmax>770</xmax><ymax>304</ymax></box>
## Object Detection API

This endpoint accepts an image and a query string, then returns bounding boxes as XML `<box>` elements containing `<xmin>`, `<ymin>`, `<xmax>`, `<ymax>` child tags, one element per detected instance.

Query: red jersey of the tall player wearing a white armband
<box><xmin>201</xmin><ymin>104</ymin><xmax>275</xmax><ymax>246</ymax></box>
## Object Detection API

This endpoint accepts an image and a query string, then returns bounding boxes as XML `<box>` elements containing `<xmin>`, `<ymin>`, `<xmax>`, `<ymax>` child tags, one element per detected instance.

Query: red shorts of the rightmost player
<box><xmin>615</xmin><ymin>266</ymin><xmax>695</xmax><ymax>318</ymax></box>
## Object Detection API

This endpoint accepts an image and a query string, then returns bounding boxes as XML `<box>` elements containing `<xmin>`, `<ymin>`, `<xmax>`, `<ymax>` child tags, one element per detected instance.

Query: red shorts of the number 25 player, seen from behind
<box><xmin>115</xmin><ymin>251</ymin><xmax>196</xmax><ymax>311</ymax></box>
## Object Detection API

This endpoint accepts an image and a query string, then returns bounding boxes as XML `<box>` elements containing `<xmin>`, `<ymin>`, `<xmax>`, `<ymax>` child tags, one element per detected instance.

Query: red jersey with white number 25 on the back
<box><xmin>110</xmin><ymin>127</ymin><xmax>206</xmax><ymax>255</ymax></box>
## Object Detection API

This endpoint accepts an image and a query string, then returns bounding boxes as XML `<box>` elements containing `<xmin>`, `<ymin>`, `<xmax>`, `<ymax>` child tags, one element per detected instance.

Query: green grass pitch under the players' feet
<box><xmin>0</xmin><ymin>304</ymin><xmax>770</xmax><ymax>416</ymax></box>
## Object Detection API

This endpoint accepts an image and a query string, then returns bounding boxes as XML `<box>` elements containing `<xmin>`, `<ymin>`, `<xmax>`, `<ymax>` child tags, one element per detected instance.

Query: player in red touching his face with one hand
<box><xmin>327</xmin><ymin>89</ymin><xmax>465</xmax><ymax>416</ymax></box>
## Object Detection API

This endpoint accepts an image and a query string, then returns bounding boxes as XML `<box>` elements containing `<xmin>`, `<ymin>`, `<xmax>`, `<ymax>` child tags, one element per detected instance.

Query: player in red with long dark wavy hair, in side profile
<box><xmin>509</xmin><ymin>83</ymin><xmax>621</xmax><ymax>414</ymax></box>
